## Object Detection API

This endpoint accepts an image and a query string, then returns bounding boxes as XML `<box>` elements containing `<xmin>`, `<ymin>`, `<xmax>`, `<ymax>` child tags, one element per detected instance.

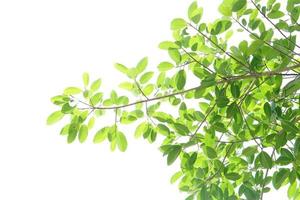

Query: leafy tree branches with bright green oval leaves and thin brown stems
<box><xmin>47</xmin><ymin>0</ymin><xmax>300</xmax><ymax>200</ymax></box>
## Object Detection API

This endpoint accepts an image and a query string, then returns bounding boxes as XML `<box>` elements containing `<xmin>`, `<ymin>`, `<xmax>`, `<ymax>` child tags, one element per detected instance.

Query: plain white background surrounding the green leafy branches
<box><xmin>0</xmin><ymin>0</ymin><xmax>286</xmax><ymax>200</ymax></box>
